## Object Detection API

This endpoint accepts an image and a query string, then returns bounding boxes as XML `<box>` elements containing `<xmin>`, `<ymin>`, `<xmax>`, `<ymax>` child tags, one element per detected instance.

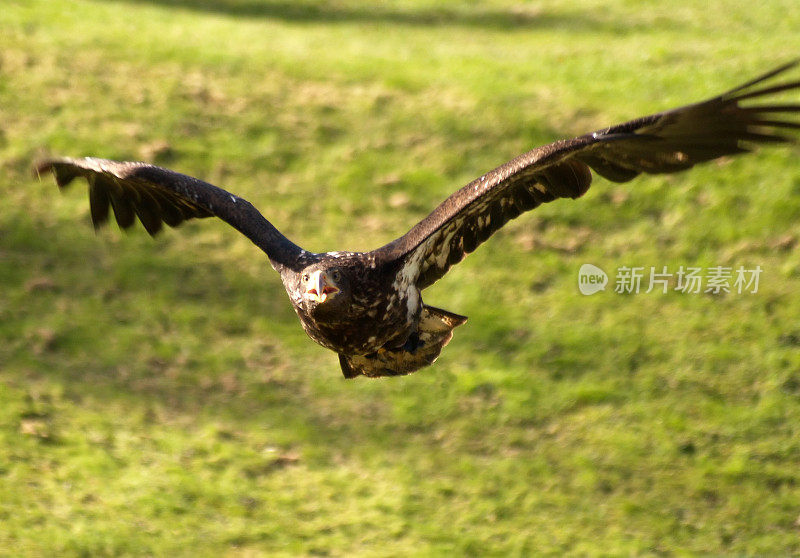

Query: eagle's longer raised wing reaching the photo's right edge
<box><xmin>372</xmin><ymin>60</ymin><xmax>800</xmax><ymax>289</ymax></box>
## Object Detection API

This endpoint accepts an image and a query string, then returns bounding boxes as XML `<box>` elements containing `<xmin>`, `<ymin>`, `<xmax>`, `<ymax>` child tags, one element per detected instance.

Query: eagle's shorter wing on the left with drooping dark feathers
<box><xmin>36</xmin><ymin>157</ymin><xmax>305</xmax><ymax>268</ymax></box>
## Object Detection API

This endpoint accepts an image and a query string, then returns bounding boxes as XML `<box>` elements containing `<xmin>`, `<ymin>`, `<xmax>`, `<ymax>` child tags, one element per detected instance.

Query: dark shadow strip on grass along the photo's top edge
<box><xmin>106</xmin><ymin>0</ymin><xmax>668</xmax><ymax>33</ymax></box>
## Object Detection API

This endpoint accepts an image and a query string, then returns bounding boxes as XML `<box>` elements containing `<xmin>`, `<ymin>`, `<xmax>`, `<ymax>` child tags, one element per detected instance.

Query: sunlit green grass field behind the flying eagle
<box><xmin>0</xmin><ymin>0</ymin><xmax>800</xmax><ymax>556</ymax></box>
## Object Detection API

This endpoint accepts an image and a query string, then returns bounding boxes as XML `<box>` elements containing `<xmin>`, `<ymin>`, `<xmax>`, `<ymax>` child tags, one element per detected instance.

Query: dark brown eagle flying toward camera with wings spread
<box><xmin>36</xmin><ymin>60</ymin><xmax>800</xmax><ymax>378</ymax></box>
